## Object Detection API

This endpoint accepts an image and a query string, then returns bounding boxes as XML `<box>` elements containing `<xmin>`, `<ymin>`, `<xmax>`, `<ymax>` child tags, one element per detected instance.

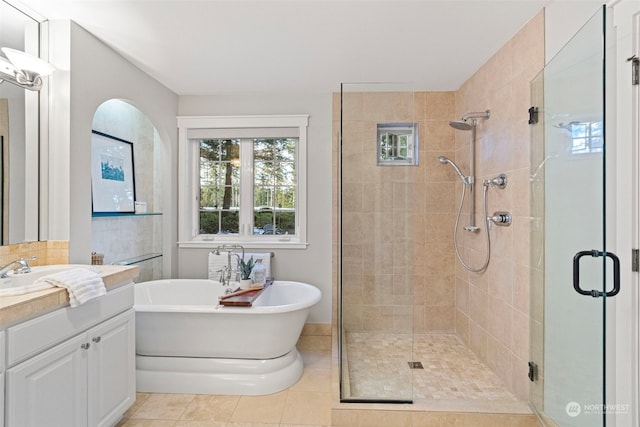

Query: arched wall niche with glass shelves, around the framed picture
<box><xmin>90</xmin><ymin>99</ymin><xmax>163</xmax><ymax>281</ymax></box>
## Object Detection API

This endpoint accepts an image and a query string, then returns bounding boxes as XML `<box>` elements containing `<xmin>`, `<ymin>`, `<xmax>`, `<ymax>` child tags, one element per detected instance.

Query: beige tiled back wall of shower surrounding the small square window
<box><xmin>334</xmin><ymin>92</ymin><xmax>457</xmax><ymax>333</ymax></box>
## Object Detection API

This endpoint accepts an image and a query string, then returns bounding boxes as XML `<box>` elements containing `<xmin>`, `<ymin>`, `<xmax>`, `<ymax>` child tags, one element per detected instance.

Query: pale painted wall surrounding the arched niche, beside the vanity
<box><xmin>41</xmin><ymin>20</ymin><xmax>178</xmax><ymax>278</ymax></box>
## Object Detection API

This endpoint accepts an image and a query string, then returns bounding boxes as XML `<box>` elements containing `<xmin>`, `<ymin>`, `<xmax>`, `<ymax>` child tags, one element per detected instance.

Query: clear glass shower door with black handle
<box><xmin>529</xmin><ymin>7</ymin><xmax>619</xmax><ymax>427</ymax></box>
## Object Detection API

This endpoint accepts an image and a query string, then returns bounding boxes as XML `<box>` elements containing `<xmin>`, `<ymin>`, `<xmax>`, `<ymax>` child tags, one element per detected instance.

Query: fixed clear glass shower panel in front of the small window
<box><xmin>338</xmin><ymin>83</ymin><xmax>420</xmax><ymax>403</ymax></box>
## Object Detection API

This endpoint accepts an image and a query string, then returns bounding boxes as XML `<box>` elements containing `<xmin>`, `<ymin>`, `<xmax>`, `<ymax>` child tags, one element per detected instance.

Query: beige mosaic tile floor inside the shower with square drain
<box><xmin>346</xmin><ymin>332</ymin><xmax>517</xmax><ymax>401</ymax></box>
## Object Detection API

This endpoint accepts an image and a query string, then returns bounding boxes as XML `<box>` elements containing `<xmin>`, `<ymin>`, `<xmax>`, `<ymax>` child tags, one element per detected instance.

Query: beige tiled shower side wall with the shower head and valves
<box><xmin>455</xmin><ymin>12</ymin><xmax>544</xmax><ymax>400</ymax></box>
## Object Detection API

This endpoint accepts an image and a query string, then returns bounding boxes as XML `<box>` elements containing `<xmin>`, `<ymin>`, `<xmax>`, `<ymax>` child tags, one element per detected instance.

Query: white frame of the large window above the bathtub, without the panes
<box><xmin>177</xmin><ymin>115</ymin><xmax>309</xmax><ymax>249</ymax></box>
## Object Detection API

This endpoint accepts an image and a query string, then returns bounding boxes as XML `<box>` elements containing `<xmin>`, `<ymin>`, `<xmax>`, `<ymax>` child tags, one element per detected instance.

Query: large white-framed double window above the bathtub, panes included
<box><xmin>178</xmin><ymin>116</ymin><xmax>308</xmax><ymax>248</ymax></box>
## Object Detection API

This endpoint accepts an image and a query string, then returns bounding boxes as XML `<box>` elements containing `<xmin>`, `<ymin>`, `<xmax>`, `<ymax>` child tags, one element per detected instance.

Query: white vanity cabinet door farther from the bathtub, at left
<box><xmin>5</xmin><ymin>334</ymin><xmax>88</xmax><ymax>427</ymax></box>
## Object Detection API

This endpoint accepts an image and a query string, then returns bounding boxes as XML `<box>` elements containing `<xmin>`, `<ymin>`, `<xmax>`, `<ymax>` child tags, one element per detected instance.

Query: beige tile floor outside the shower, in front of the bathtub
<box><xmin>117</xmin><ymin>337</ymin><xmax>331</xmax><ymax>427</ymax></box>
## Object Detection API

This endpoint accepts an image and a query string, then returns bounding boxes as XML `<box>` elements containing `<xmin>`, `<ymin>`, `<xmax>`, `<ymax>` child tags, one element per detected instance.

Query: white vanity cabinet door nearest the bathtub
<box><xmin>87</xmin><ymin>309</ymin><xmax>136</xmax><ymax>427</ymax></box>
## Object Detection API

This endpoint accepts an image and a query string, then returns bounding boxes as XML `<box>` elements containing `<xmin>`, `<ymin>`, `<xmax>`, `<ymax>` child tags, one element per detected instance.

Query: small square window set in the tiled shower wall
<box><xmin>377</xmin><ymin>123</ymin><xmax>418</xmax><ymax>166</ymax></box>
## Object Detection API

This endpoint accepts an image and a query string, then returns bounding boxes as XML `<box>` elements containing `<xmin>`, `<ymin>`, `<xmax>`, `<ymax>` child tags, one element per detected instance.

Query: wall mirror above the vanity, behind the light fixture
<box><xmin>0</xmin><ymin>1</ymin><xmax>44</xmax><ymax>245</ymax></box>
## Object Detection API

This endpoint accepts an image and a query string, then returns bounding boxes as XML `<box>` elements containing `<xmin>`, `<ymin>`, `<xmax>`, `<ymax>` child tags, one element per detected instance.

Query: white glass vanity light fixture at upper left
<box><xmin>0</xmin><ymin>47</ymin><xmax>55</xmax><ymax>91</ymax></box>
